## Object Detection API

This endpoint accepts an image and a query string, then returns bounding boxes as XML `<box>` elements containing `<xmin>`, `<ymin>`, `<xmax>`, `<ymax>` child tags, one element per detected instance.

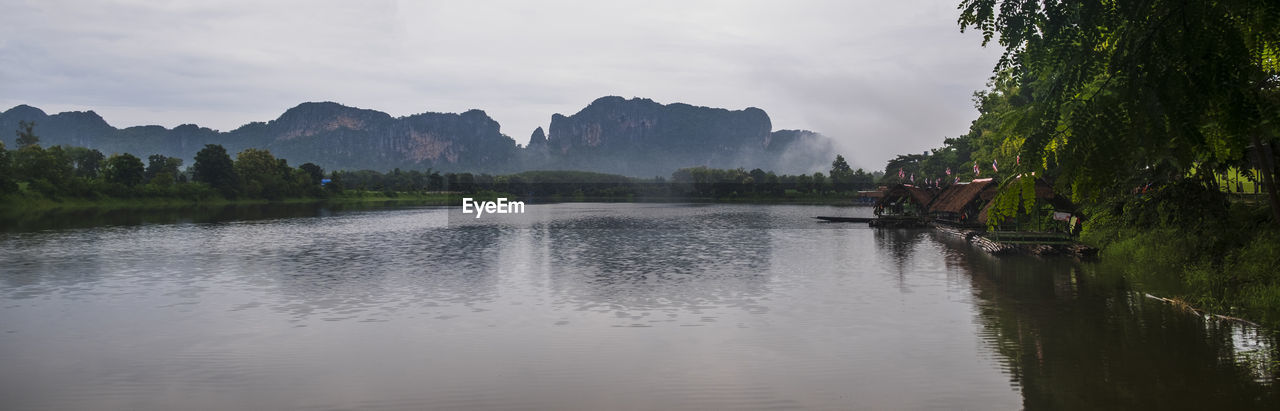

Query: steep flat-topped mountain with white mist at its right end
<box><xmin>529</xmin><ymin>96</ymin><xmax>835</xmax><ymax>175</ymax></box>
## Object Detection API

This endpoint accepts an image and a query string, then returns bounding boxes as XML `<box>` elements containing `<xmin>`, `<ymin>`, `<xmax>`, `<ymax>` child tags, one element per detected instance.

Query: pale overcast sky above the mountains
<box><xmin>0</xmin><ymin>0</ymin><xmax>1000</xmax><ymax>169</ymax></box>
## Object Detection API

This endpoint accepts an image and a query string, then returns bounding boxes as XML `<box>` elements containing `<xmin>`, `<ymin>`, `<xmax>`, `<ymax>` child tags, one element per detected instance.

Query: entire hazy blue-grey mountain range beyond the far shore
<box><xmin>0</xmin><ymin>97</ymin><xmax>835</xmax><ymax>177</ymax></box>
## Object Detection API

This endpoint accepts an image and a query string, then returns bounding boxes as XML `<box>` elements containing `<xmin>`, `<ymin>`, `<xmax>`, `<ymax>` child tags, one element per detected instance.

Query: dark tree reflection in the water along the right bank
<box><xmin>947</xmin><ymin>238</ymin><xmax>1280</xmax><ymax>410</ymax></box>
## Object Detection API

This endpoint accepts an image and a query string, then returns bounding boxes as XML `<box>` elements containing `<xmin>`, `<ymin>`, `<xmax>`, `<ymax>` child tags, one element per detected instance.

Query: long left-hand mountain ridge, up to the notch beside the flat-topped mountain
<box><xmin>0</xmin><ymin>102</ymin><xmax>518</xmax><ymax>173</ymax></box>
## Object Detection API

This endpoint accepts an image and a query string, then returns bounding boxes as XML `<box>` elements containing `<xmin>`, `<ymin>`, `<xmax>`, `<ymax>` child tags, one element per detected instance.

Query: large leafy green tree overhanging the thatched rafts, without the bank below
<box><xmin>959</xmin><ymin>0</ymin><xmax>1280</xmax><ymax>222</ymax></box>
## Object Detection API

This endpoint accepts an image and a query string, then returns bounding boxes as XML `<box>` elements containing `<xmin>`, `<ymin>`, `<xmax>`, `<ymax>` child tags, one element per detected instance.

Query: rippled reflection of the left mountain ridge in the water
<box><xmin>266</xmin><ymin>222</ymin><xmax>499</xmax><ymax>318</ymax></box>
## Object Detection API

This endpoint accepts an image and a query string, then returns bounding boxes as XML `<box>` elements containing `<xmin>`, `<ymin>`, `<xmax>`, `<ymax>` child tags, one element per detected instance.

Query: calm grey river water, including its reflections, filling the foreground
<box><xmin>0</xmin><ymin>204</ymin><xmax>1280</xmax><ymax>410</ymax></box>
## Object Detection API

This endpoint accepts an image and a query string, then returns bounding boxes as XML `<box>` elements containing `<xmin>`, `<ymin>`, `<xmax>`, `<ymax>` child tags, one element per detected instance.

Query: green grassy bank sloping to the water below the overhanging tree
<box><xmin>1082</xmin><ymin>190</ymin><xmax>1280</xmax><ymax>328</ymax></box>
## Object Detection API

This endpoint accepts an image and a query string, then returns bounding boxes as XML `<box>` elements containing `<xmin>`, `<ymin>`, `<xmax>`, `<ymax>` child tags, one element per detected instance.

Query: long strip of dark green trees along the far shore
<box><xmin>0</xmin><ymin>123</ymin><xmax>877</xmax><ymax>201</ymax></box>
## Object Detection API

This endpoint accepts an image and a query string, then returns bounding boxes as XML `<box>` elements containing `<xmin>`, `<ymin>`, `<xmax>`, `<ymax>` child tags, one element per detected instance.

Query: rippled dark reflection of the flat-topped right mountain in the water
<box><xmin>545</xmin><ymin>212</ymin><xmax>771</xmax><ymax>310</ymax></box>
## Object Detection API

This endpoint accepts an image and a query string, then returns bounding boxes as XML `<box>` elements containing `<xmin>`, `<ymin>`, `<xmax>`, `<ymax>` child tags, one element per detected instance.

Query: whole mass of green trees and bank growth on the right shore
<box><xmin>849</xmin><ymin>0</ymin><xmax>1280</xmax><ymax>324</ymax></box>
